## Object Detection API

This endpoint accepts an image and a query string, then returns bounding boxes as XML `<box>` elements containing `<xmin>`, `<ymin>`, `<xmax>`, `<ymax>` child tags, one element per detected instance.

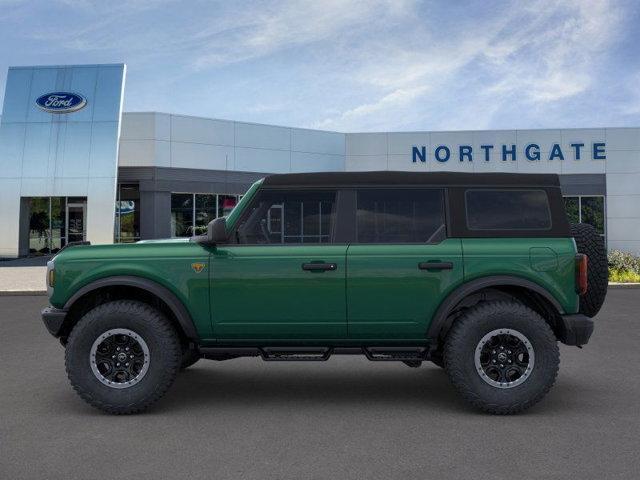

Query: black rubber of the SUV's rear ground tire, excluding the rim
<box><xmin>444</xmin><ymin>301</ymin><xmax>560</xmax><ymax>415</ymax></box>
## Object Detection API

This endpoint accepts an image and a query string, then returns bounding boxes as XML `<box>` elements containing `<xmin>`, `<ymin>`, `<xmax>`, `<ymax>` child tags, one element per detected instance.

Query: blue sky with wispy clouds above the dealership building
<box><xmin>0</xmin><ymin>0</ymin><xmax>640</xmax><ymax>132</ymax></box>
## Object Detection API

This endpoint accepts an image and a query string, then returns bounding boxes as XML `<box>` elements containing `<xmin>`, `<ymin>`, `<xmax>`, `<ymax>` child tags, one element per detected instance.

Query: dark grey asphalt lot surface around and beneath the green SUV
<box><xmin>0</xmin><ymin>289</ymin><xmax>640</xmax><ymax>480</ymax></box>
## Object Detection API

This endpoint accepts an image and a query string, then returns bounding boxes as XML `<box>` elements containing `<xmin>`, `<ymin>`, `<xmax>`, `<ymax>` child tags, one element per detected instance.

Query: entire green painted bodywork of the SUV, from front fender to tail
<box><xmin>50</xmin><ymin>181</ymin><xmax>578</xmax><ymax>345</ymax></box>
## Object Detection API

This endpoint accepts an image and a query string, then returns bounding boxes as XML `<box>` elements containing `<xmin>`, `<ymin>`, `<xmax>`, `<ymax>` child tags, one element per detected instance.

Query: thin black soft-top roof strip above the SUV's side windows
<box><xmin>263</xmin><ymin>171</ymin><xmax>560</xmax><ymax>187</ymax></box>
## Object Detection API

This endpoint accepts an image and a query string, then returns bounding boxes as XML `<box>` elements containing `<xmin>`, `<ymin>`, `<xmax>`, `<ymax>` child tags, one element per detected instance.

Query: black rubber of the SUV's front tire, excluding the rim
<box><xmin>65</xmin><ymin>300</ymin><xmax>182</xmax><ymax>414</ymax></box>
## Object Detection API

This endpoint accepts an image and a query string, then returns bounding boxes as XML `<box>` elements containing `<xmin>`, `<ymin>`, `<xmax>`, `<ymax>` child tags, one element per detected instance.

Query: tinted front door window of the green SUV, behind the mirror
<box><xmin>236</xmin><ymin>190</ymin><xmax>336</xmax><ymax>245</ymax></box>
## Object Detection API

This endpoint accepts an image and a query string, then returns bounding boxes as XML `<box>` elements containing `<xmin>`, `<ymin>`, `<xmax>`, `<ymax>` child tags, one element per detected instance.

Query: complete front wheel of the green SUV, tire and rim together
<box><xmin>65</xmin><ymin>300</ymin><xmax>182</xmax><ymax>414</ymax></box>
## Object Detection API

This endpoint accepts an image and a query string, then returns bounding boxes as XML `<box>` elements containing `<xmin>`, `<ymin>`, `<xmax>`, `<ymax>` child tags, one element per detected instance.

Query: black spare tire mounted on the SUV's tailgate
<box><xmin>571</xmin><ymin>223</ymin><xmax>609</xmax><ymax>317</ymax></box>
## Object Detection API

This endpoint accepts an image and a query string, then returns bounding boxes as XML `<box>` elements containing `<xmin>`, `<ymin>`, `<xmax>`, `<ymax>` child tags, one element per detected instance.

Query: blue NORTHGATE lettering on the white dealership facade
<box><xmin>411</xmin><ymin>142</ymin><xmax>607</xmax><ymax>163</ymax></box>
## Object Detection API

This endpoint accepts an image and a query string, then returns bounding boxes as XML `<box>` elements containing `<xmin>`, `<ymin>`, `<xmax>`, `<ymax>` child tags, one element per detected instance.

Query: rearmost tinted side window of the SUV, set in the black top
<box><xmin>465</xmin><ymin>189</ymin><xmax>551</xmax><ymax>230</ymax></box>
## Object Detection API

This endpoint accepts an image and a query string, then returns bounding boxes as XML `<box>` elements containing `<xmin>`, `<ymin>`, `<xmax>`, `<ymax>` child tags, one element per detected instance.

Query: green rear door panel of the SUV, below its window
<box><xmin>347</xmin><ymin>238</ymin><xmax>463</xmax><ymax>340</ymax></box>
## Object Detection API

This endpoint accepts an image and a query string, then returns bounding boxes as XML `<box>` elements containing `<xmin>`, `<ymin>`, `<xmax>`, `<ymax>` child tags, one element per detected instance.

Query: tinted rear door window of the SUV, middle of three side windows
<box><xmin>357</xmin><ymin>189</ymin><xmax>446</xmax><ymax>243</ymax></box>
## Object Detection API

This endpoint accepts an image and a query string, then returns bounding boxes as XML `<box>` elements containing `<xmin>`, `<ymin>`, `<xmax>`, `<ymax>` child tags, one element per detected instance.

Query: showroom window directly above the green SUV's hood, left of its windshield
<box><xmin>171</xmin><ymin>193</ymin><xmax>240</xmax><ymax>237</ymax></box>
